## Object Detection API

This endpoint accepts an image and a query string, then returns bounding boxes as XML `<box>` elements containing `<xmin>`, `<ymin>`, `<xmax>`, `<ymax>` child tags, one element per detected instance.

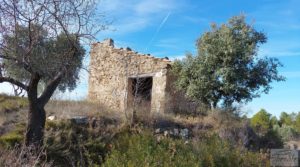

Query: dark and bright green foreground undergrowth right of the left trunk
<box><xmin>0</xmin><ymin>118</ymin><xmax>269</xmax><ymax>167</ymax></box>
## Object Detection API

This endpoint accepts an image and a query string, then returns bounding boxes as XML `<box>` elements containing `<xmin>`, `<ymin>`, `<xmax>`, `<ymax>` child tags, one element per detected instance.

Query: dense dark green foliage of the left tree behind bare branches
<box><xmin>3</xmin><ymin>25</ymin><xmax>85</xmax><ymax>91</ymax></box>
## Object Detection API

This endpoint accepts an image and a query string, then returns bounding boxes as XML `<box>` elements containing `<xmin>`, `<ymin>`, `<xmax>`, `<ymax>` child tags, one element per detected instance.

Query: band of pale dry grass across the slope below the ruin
<box><xmin>0</xmin><ymin>94</ymin><xmax>246</xmax><ymax>142</ymax></box>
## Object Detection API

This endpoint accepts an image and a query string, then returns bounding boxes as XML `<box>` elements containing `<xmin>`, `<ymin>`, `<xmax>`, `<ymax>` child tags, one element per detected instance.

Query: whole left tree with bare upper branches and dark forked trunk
<box><xmin>0</xmin><ymin>0</ymin><xmax>105</xmax><ymax>146</ymax></box>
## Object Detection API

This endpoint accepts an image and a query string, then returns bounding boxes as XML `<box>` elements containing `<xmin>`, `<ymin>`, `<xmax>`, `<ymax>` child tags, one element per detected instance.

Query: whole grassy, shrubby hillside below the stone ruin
<box><xmin>0</xmin><ymin>95</ymin><xmax>274</xmax><ymax>166</ymax></box>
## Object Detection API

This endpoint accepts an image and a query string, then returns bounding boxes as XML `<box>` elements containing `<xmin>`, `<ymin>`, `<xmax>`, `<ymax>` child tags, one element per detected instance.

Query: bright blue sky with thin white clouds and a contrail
<box><xmin>0</xmin><ymin>0</ymin><xmax>300</xmax><ymax>116</ymax></box>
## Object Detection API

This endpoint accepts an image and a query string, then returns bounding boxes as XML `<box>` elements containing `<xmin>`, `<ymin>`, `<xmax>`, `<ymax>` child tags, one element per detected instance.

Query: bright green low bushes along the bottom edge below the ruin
<box><xmin>103</xmin><ymin>132</ymin><xmax>268</xmax><ymax>167</ymax></box>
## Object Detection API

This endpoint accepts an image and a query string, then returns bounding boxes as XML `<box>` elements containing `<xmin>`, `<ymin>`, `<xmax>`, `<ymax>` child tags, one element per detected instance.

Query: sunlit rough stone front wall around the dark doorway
<box><xmin>88</xmin><ymin>39</ymin><xmax>171</xmax><ymax>112</ymax></box>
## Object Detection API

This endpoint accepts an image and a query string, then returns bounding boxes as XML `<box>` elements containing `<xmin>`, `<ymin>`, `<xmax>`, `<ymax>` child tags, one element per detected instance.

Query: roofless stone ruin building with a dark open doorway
<box><xmin>88</xmin><ymin>39</ymin><xmax>190</xmax><ymax>112</ymax></box>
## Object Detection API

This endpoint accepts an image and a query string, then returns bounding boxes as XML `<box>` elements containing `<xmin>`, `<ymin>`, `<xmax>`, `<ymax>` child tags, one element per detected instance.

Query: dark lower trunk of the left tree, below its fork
<box><xmin>25</xmin><ymin>99</ymin><xmax>46</xmax><ymax>147</ymax></box>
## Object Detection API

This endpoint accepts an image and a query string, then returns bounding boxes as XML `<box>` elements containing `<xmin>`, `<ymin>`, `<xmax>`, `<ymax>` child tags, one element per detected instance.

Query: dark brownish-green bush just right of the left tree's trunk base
<box><xmin>44</xmin><ymin>121</ymin><xmax>108</xmax><ymax>166</ymax></box>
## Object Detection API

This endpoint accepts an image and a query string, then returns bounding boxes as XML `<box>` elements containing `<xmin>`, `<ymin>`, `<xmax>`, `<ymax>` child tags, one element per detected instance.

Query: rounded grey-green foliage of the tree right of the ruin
<box><xmin>173</xmin><ymin>16</ymin><xmax>284</xmax><ymax>107</ymax></box>
